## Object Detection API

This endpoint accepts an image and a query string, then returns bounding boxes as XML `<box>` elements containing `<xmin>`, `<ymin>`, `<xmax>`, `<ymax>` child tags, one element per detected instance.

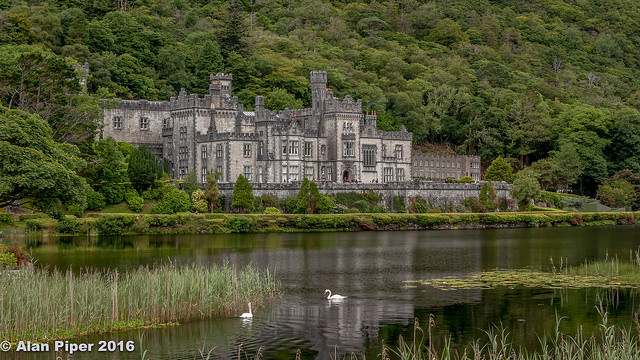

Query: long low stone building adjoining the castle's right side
<box><xmin>411</xmin><ymin>152</ymin><xmax>480</xmax><ymax>181</ymax></box>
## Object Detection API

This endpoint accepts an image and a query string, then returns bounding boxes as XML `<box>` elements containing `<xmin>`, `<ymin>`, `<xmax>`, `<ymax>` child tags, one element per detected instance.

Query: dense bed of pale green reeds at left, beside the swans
<box><xmin>0</xmin><ymin>264</ymin><xmax>279</xmax><ymax>342</ymax></box>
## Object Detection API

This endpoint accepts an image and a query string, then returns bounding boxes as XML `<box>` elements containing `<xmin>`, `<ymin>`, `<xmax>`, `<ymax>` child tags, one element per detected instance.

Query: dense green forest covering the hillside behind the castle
<box><xmin>0</xmin><ymin>0</ymin><xmax>640</xmax><ymax>194</ymax></box>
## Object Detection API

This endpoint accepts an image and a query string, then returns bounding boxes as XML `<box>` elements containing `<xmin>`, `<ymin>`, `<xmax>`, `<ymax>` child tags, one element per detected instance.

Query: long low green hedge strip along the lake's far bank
<box><xmin>4</xmin><ymin>211</ymin><xmax>640</xmax><ymax>238</ymax></box>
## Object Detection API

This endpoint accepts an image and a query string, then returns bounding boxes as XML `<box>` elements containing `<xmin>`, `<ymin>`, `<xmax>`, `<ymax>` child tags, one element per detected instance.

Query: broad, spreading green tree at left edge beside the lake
<box><xmin>0</xmin><ymin>106</ymin><xmax>88</xmax><ymax>213</ymax></box>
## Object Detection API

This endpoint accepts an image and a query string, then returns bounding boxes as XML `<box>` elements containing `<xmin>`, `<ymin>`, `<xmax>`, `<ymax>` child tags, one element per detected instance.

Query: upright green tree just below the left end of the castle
<box><xmin>93</xmin><ymin>137</ymin><xmax>129</xmax><ymax>204</ymax></box>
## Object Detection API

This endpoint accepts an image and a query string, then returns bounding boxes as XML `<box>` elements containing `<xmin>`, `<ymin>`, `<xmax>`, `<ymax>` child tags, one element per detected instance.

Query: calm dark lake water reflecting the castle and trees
<box><xmin>5</xmin><ymin>226</ymin><xmax>640</xmax><ymax>359</ymax></box>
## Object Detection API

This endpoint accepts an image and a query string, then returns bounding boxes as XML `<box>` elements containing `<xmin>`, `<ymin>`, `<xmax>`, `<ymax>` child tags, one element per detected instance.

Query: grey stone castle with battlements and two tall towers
<box><xmin>103</xmin><ymin>71</ymin><xmax>412</xmax><ymax>182</ymax></box>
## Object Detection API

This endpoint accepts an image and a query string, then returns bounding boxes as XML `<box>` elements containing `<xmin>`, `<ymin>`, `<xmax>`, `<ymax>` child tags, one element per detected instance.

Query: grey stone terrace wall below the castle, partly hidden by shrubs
<box><xmin>219</xmin><ymin>181</ymin><xmax>511</xmax><ymax>211</ymax></box>
